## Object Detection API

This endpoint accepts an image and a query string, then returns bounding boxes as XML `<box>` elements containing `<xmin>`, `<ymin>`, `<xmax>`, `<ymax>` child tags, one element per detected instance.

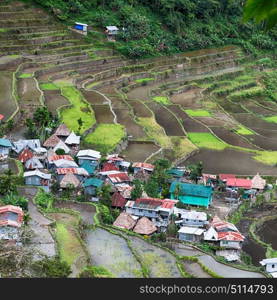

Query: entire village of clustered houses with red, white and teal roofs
<box><xmin>0</xmin><ymin>124</ymin><xmax>277</xmax><ymax>277</ymax></box>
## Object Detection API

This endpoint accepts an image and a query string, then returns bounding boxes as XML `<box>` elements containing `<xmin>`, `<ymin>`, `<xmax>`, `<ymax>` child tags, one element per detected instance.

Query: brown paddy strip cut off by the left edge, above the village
<box><xmin>0</xmin><ymin>72</ymin><xmax>16</xmax><ymax>121</ymax></box>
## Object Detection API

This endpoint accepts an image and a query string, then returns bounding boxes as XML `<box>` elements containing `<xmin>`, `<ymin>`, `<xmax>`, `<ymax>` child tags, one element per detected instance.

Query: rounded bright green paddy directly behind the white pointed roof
<box><xmin>85</xmin><ymin>124</ymin><xmax>126</xmax><ymax>153</ymax></box>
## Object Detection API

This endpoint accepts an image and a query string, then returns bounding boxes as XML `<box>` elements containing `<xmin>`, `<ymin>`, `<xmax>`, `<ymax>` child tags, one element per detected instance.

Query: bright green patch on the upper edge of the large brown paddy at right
<box><xmin>185</xmin><ymin>132</ymin><xmax>228</xmax><ymax>150</ymax></box>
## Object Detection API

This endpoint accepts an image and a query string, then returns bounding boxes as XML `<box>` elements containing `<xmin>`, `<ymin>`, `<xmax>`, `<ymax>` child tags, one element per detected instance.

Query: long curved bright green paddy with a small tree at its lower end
<box><xmin>61</xmin><ymin>86</ymin><xmax>96</xmax><ymax>134</ymax></box>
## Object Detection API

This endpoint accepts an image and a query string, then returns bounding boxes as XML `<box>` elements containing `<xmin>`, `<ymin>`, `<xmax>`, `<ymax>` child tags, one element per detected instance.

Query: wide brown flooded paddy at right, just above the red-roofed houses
<box><xmin>181</xmin><ymin>149</ymin><xmax>276</xmax><ymax>175</ymax></box>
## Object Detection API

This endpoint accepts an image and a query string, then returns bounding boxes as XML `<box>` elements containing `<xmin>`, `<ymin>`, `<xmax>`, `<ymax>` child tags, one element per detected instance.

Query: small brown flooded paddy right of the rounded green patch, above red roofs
<box><xmin>121</xmin><ymin>142</ymin><xmax>160</xmax><ymax>162</ymax></box>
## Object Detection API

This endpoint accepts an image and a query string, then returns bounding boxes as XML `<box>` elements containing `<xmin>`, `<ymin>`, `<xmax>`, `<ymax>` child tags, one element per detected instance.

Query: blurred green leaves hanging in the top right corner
<box><xmin>243</xmin><ymin>0</ymin><xmax>277</xmax><ymax>29</ymax></box>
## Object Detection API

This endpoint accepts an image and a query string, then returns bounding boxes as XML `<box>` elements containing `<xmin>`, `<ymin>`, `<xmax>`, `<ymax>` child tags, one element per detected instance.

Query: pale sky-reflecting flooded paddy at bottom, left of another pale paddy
<box><xmin>85</xmin><ymin>228</ymin><xmax>142</xmax><ymax>278</ymax></box>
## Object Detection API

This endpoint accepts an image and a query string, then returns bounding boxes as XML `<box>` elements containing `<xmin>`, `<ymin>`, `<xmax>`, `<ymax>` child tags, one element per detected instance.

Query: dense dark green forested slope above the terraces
<box><xmin>25</xmin><ymin>0</ymin><xmax>276</xmax><ymax>58</ymax></box>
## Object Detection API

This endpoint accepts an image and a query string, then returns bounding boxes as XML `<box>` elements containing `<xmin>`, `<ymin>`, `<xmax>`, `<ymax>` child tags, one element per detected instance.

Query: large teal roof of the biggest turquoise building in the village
<box><xmin>169</xmin><ymin>181</ymin><xmax>213</xmax><ymax>198</ymax></box>
